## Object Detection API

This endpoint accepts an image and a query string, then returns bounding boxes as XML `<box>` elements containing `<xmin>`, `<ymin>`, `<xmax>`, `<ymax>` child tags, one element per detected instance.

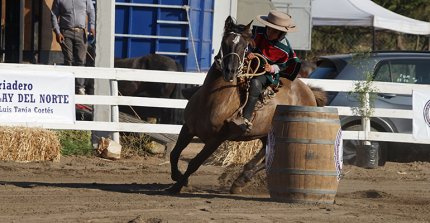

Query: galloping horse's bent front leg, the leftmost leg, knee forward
<box><xmin>170</xmin><ymin>124</ymin><xmax>193</xmax><ymax>181</ymax></box>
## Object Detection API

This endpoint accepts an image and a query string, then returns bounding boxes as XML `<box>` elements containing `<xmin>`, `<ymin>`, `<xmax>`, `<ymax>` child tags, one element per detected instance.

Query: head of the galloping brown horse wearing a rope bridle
<box><xmin>217</xmin><ymin>16</ymin><xmax>253</xmax><ymax>82</ymax></box>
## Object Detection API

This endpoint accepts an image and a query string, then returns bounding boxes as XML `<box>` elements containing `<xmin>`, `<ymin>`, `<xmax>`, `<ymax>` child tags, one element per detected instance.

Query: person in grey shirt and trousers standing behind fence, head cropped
<box><xmin>51</xmin><ymin>0</ymin><xmax>96</xmax><ymax>94</ymax></box>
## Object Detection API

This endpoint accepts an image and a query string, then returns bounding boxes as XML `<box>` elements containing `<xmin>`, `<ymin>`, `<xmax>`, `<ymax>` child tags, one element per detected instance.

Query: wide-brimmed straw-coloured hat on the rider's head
<box><xmin>256</xmin><ymin>10</ymin><xmax>296</xmax><ymax>32</ymax></box>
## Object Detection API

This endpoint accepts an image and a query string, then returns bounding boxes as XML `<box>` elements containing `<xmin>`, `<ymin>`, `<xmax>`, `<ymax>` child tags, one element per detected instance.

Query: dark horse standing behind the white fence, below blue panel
<box><xmin>114</xmin><ymin>54</ymin><xmax>183</xmax><ymax>123</ymax></box>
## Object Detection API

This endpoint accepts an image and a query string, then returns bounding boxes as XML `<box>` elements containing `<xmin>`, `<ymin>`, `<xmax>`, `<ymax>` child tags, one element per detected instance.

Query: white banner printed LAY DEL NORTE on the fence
<box><xmin>0</xmin><ymin>70</ymin><xmax>75</xmax><ymax>123</ymax></box>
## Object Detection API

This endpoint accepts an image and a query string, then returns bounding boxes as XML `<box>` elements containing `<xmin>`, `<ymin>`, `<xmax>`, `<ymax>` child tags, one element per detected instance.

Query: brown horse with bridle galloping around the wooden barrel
<box><xmin>167</xmin><ymin>16</ymin><xmax>324</xmax><ymax>194</ymax></box>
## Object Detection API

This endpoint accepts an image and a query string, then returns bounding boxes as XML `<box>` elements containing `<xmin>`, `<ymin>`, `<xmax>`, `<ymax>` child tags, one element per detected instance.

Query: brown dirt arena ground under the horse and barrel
<box><xmin>0</xmin><ymin>145</ymin><xmax>430</xmax><ymax>223</ymax></box>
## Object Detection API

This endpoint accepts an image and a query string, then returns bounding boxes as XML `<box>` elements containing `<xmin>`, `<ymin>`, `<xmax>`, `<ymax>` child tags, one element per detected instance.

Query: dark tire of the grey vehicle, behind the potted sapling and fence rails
<box><xmin>343</xmin><ymin>125</ymin><xmax>387</xmax><ymax>166</ymax></box>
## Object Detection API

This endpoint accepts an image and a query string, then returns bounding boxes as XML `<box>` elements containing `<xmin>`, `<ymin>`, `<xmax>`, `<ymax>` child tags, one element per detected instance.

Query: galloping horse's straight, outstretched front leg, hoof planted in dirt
<box><xmin>167</xmin><ymin>138</ymin><xmax>224</xmax><ymax>194</ymax></box>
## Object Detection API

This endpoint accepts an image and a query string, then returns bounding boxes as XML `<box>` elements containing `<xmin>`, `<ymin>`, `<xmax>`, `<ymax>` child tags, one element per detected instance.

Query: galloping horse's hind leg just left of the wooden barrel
<box><xmin>230</xmin><ymin>137</ymin><xmax>267</xmax><ymax>194</ymax></box>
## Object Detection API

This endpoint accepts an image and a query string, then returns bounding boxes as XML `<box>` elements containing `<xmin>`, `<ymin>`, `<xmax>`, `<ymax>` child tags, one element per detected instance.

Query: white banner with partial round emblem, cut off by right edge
<box><xmin>412</xmin><ymin>91</ymin><xmax>430</xmax><ymax>139</ymax></box>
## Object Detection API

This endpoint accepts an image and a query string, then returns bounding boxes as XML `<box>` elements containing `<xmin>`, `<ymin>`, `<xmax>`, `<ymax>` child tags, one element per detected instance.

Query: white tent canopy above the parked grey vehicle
<box><xmin>312</xmin><ymin>0</ymin><xmax>430</xmax><ymax>35</ymax></box>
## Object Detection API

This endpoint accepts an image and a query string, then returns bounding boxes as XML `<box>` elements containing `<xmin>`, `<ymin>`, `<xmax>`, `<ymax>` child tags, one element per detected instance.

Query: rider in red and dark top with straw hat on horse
<box><xmin>234</xmin><ymin>10</ymin><xmax>301</xmax><ymax>132</ymax></box>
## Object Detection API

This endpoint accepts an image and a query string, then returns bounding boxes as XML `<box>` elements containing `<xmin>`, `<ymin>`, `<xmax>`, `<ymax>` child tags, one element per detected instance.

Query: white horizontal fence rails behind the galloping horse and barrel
<box><xmin>0</xmin><ymin>64</ymin><xmax>430</xmax><ymax>144</ymax></box>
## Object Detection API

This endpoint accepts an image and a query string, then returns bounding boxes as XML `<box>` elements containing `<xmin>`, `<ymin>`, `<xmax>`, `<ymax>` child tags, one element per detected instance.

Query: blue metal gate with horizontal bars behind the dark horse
<box><xmin>115</xmin><ymin>0</ymin><xmax>214</xmax><ymax>71</ymax></box>
